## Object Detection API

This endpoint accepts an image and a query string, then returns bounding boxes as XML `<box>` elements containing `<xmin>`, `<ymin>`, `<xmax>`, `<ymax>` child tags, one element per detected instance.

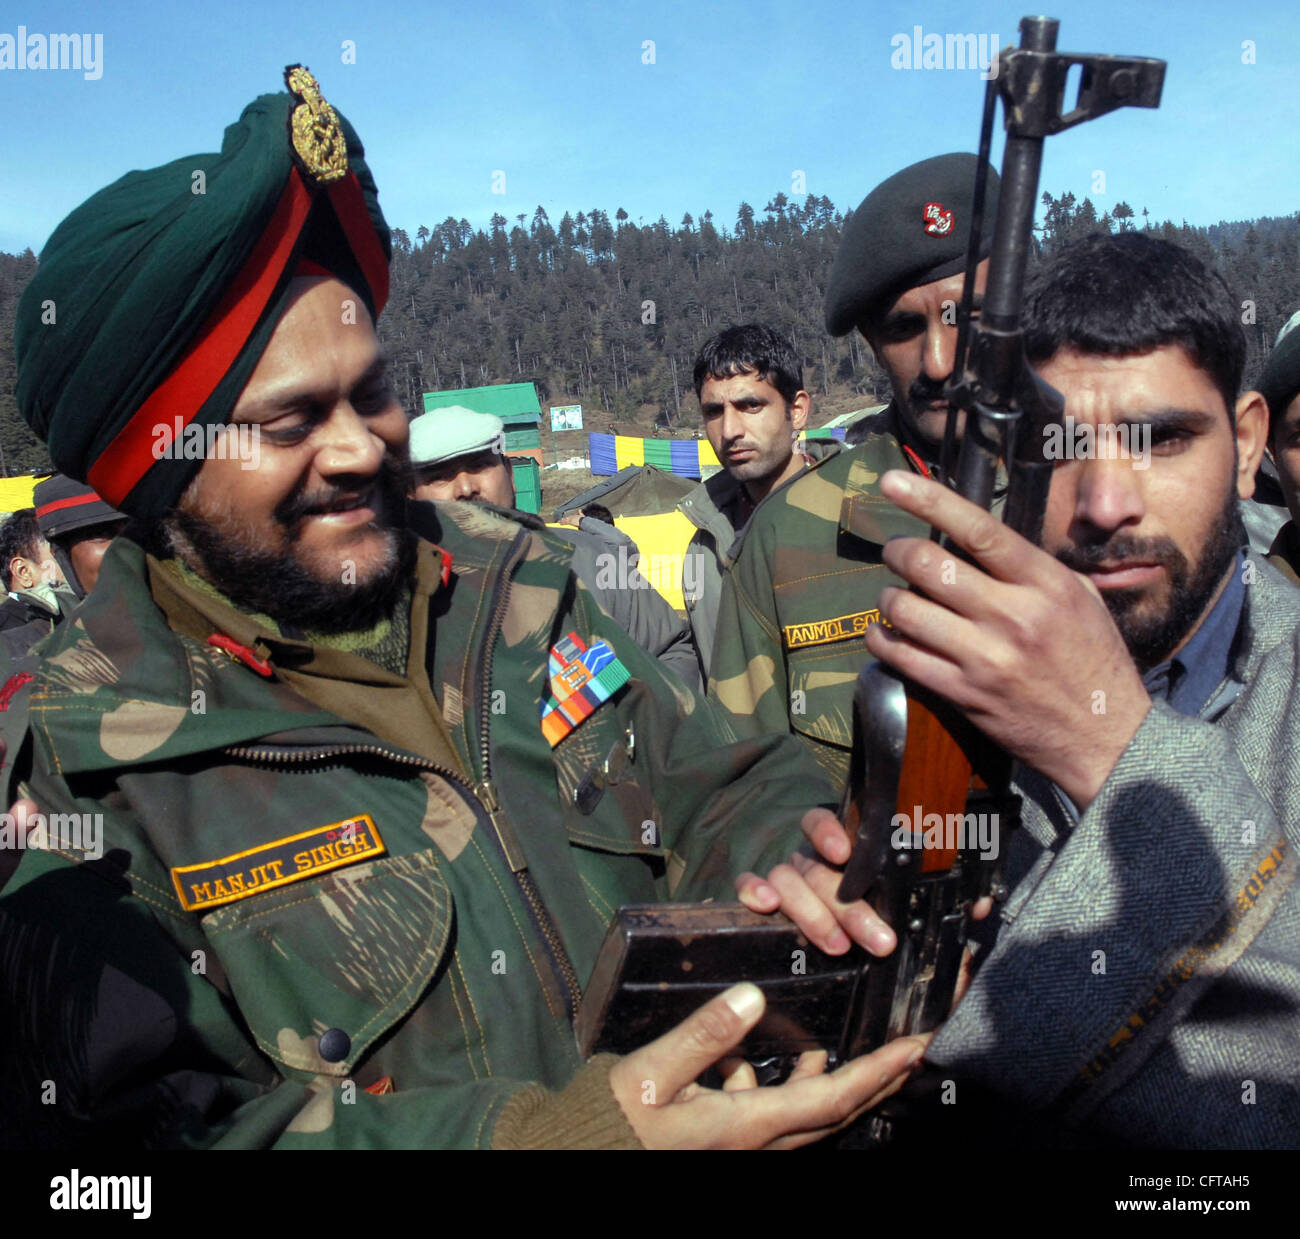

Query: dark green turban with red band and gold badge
<box><xmin>14</xmin><ymin>65</ymin><xmax>391</xmax><ymax>519</ymax></box>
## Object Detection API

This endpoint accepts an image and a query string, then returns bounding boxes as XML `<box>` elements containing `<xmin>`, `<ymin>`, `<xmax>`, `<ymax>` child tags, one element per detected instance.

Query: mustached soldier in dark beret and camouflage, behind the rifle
<box><xmin>709</xmin><ymin>155</ymin><xmax>998</xmax><ymax>785</ymax></box>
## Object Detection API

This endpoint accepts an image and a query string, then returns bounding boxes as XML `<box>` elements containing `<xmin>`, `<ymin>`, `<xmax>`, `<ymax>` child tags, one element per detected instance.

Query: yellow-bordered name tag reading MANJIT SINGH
<box><xmin>172</xmin><ymin>813</ymin><xmax>387</xmax><ymax>911</ymax></box>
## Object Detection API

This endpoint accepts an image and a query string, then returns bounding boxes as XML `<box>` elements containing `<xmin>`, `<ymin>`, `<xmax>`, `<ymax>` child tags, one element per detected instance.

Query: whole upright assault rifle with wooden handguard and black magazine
<box><xmin>577</xmin><ymin>17</ymin><xmax>1165</xmax><ymax>1080</ymax></box>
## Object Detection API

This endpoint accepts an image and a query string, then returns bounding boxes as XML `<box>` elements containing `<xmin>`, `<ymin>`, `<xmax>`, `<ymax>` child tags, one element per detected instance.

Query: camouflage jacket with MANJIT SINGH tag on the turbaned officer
<box><xmin>0</xmin><ymin>503</ymin><xmax>831</xmax><ymax>1148</ymax></box>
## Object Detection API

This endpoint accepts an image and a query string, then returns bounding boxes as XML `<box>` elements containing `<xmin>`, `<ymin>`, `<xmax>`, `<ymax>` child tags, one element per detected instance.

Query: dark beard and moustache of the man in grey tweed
<box><xmin>1056</xmin><ymin>484</ymin><xmax>1247</xmax><ymax>672</ymax></box>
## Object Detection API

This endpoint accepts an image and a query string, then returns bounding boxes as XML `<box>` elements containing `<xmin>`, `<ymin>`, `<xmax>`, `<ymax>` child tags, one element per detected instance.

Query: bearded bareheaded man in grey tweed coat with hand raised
<box><xmin>754</xmin><ymin>233</ymin><xmax>1300</xmax><ymax>1148</ymax></box>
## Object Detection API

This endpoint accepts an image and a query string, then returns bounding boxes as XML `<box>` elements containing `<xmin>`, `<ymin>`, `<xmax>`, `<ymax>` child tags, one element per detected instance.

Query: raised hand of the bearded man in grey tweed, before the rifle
<box><xmin>866</xmin><ymin>471</ymin><xmax>1151</xmax><ymax>811</ymax></box>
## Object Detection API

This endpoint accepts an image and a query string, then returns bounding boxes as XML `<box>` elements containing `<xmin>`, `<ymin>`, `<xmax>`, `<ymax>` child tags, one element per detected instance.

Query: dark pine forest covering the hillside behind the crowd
<box><xmin>0</xmin><ymin>194</ymin><xmax>1300</xmax><ymax>475</ymax></box>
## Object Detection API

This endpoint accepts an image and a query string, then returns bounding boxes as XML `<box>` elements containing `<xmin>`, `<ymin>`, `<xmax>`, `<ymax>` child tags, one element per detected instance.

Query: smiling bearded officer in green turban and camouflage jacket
<box><xmin>0</xmin><ymin>66</ymin><xmax>920</xmax><ymax>1148</ymax></box>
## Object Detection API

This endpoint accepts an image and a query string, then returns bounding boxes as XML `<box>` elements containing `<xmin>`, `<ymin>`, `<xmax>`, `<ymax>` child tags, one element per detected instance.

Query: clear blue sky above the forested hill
<box><xmin>0</xmin><ymin>0</ymin><xmax>1300</xmax><ymax>252</ymax></box>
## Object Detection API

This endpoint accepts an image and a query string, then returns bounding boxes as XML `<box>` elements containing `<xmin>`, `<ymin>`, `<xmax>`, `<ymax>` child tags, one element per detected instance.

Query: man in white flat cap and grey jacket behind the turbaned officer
<box><xmin>408</xmin><ymin>404</ymin><xmax>701</xmax><ymax>688</ymax></box>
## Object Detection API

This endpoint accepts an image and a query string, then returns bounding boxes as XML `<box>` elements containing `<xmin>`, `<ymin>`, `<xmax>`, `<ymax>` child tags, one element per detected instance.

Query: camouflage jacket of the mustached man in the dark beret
<box><xmin>709</xmin><ymin>433</ymin><xmax>930</xmax><ymax>787</ymax></box>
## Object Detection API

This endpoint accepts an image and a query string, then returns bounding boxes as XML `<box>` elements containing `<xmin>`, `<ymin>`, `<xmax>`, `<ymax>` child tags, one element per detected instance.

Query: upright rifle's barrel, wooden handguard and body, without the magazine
<box><xmin>839</xmin><ymin>17</ymin><xmax>1165</xmax><ymax>1053</ymax></box>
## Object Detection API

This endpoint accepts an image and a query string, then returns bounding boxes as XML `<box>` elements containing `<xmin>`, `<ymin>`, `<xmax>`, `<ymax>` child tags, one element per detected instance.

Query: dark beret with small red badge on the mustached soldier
<box><xmin>826</xmin><ymin>153</ymin><xmax>1000</xmax><ymax>335</ymax></box>
